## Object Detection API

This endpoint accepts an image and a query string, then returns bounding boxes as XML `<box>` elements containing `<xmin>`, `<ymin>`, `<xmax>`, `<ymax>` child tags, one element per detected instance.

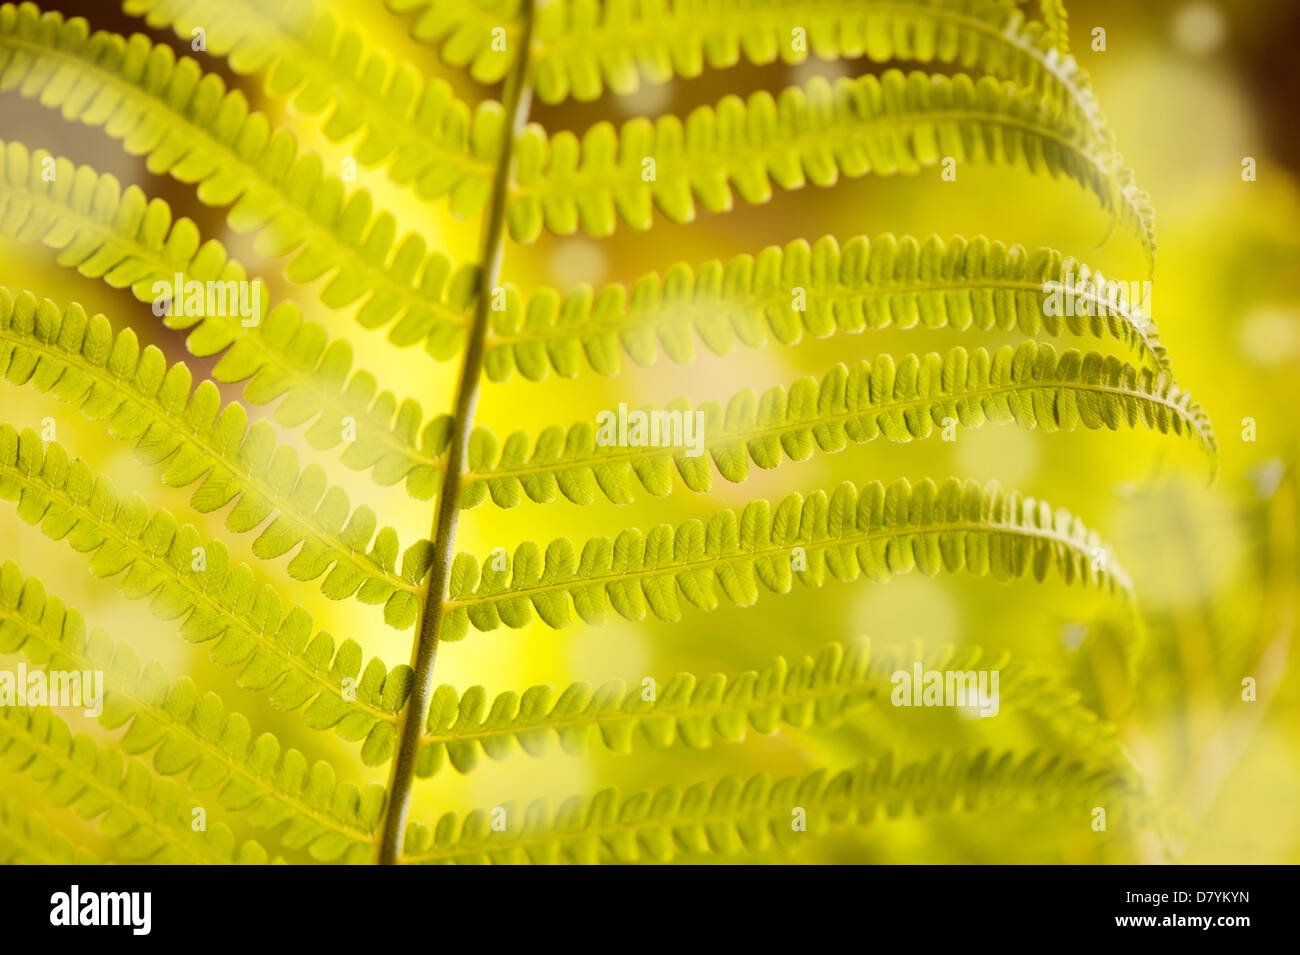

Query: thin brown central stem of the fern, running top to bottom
<box><xmin>378</xmin><ymin>0</ymin><xmax>534</xmax><ymax>865</ymax></box>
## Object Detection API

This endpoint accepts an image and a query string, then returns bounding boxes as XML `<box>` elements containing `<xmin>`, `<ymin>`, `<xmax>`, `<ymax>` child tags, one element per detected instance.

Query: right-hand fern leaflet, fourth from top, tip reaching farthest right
<box><xmin>462</xmin><ymin>342</ymin><xmax>1216</xmax><ymax>508</ymax></box>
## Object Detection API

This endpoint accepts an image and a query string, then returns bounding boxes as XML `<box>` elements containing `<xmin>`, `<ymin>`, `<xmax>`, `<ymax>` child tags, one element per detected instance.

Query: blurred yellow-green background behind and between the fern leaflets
<box><xmin>0</xmin><ymin>0</ymin><xmax>1300</xmax><ymax>863</ymax></box>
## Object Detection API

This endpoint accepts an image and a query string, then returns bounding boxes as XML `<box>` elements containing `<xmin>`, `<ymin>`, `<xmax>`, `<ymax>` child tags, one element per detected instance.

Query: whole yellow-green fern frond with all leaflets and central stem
<box><xmin>0</xmin><ymin>0</ymin><xmax>1216</xmax><ymax>863</ymax></box>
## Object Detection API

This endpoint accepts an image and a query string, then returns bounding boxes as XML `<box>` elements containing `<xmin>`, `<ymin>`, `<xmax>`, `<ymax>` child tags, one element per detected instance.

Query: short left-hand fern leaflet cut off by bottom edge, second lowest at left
<box><xmin>0</xmin><ymin>707</ymin><xmax>268</xmax><ymax>865</ymax></box>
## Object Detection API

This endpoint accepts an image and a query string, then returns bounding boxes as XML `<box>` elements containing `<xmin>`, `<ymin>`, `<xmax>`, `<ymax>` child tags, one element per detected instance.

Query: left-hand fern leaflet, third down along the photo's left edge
<box><xmin>0</xmin><ymin>286</ymin><xmax>426</xmax><ymax>615</ymax></box>
